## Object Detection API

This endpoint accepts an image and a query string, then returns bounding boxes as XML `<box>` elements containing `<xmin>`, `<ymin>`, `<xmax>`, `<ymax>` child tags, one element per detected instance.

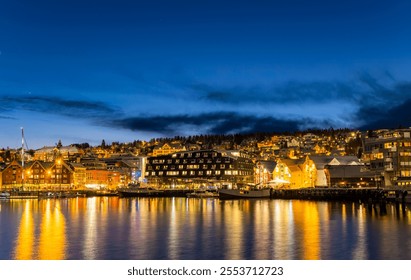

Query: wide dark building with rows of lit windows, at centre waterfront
<box><xmin>145</xmin><ymin>150</ymin><xmax>255</xmax><ymax>188</ymax></box>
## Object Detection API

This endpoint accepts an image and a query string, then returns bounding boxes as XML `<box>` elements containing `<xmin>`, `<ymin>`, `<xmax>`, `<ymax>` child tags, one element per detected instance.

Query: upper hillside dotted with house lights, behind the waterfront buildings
<box><xmin>0</xmin><ymin>128</ymin><xmax>360</xmax><ymax>162</ymax></box>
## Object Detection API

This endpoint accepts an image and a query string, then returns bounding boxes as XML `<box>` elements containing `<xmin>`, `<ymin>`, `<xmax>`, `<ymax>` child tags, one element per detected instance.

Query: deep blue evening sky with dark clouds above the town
<box><xmin>0</xmin><ymin>0</ymin><xmax>411</xmax><ymax>148</ymax></box>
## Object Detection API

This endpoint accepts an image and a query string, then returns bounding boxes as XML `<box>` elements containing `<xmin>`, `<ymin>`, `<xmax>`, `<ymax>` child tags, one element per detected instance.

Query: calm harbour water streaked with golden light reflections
<box><xmin>0</xmin><ymin>197</ymin><xmax>411</xmax><ymax>260</ymax></box>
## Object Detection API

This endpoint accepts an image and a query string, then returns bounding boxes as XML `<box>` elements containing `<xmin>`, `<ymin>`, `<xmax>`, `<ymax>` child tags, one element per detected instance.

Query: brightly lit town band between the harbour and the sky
<box><xmin>0</xmin><ymin>129</ymin><xmax>411</xmax><ymax>190</ymax></box>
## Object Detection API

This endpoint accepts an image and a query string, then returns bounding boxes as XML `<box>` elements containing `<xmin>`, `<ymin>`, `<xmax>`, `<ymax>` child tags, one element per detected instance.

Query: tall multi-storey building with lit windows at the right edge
<box><xmin>362</xmin><ymin>128</ymin><xmax>411</xmax><ymax>187</ymax></box>
